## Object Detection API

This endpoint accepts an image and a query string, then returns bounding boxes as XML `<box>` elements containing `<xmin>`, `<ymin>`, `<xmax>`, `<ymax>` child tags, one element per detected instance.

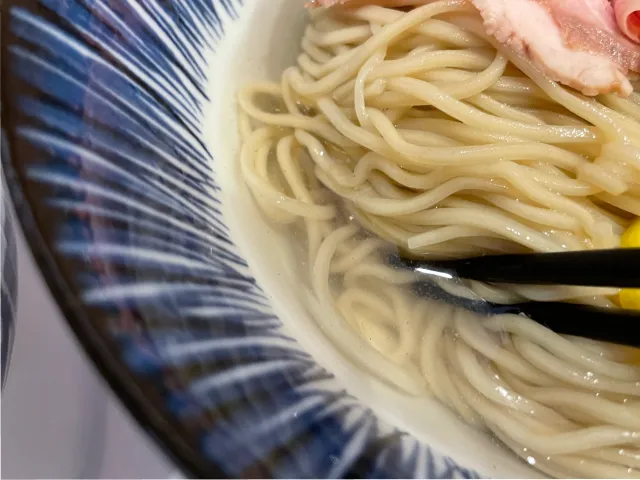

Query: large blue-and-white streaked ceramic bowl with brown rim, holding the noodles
<box><xmin>2</xmin><ymin>0</ymin><xmax>536</xmax><ymax>478</ymax></box>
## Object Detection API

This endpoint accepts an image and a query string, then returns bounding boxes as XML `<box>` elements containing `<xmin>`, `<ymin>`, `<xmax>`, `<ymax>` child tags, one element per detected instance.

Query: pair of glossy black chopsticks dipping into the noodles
<box><xmin>390</xmin><ymin>249</ymin><xmax>640</xmax><ymax>348</ymax></box>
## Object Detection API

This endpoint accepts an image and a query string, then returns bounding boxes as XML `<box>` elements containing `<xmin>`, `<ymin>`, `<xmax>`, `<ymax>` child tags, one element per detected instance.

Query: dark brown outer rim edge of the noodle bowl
<box><xmin>0</xmin><ymin>4</ymin><xmax>228</xmax><ymax>478</ymax></box>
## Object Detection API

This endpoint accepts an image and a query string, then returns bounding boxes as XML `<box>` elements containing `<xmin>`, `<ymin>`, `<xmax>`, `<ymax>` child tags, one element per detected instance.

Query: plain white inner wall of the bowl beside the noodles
<box><xmin>204</xmin><ymin>0</ymin><xmax>541</xmax><ymax>478</ymax></box>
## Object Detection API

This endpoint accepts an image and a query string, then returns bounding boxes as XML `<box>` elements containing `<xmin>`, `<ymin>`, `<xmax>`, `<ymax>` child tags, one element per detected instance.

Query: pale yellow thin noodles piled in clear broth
<box><xmin>239</xmin><ymin>0</ymin><xmax>640</xmax><ymax>478</ymax></box>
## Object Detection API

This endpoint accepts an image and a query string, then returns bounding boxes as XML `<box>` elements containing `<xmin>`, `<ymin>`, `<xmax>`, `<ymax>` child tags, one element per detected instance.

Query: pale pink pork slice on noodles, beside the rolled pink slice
<box><xmin>471</xmin><ymin>0</ymin><xmax>640</xmax><ymax>95</ymax></box>
